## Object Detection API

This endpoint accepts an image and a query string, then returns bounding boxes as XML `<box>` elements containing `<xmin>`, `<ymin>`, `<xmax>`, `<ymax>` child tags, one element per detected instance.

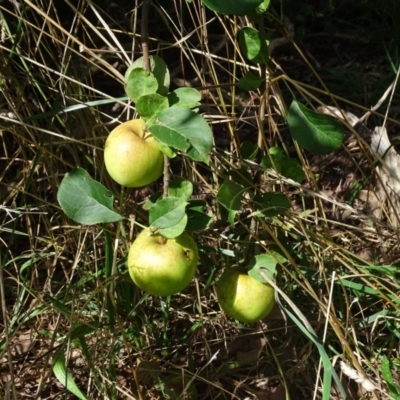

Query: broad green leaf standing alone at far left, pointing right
<box><xmin>57</xmin><ymin>168</ymin><xmax>123</xmax><ymax>225</ymax></box>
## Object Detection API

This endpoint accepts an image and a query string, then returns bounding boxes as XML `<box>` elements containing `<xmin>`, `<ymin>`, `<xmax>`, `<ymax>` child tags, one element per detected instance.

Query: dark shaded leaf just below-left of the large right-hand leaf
<box><xmin>261</xmin><ymin>147</ymin><xmax>305</xmax><ymax>183</ymax></box>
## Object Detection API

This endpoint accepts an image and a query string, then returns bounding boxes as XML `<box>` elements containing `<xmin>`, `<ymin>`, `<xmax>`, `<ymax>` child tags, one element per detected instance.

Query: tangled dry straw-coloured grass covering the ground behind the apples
<box><xmin>0</xmin><ymin>0</ymin><xmax>400</xmax><ymax>400</ymax></box>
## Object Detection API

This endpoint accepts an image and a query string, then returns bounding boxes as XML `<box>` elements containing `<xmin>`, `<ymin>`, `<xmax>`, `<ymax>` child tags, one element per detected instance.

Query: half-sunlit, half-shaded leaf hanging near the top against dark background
<box><xmin>239</xmin><ymin>27</ymin><xmax>269</xmax><ymax>64</ymax></box>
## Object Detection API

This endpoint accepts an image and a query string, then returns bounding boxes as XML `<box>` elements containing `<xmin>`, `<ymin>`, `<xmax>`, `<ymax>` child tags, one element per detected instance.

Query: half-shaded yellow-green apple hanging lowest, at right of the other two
<box><xmin>217</xmin><ymin>267</ymin><xmax>275</xmax><ymax>322</ymax></box>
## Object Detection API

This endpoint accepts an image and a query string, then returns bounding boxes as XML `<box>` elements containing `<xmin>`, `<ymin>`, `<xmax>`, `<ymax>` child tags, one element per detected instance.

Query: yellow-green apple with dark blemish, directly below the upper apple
<box><xmin>128</xmin><ymin>229</ymin><xmax>199</xmax><ymax>296</ymax></box>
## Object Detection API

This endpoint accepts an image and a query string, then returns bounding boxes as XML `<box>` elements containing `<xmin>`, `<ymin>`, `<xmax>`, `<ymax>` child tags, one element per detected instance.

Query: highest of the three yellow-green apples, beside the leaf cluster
<box><xmin>104</xmin><ymin>119</ymin><xmax>164</xmax><ymax>187</ymax></box>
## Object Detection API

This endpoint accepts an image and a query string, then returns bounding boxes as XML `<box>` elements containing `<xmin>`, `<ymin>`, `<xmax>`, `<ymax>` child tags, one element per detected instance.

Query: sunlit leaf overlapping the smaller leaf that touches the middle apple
<box><xmin>149</xmin><ymin>197</ymin><xmax>187</xmax><ymax>229</ymax></box>
